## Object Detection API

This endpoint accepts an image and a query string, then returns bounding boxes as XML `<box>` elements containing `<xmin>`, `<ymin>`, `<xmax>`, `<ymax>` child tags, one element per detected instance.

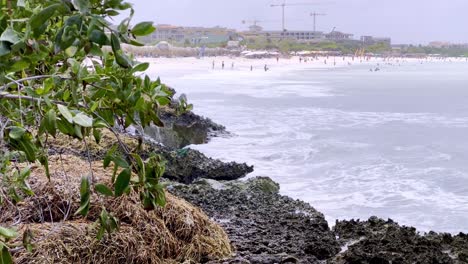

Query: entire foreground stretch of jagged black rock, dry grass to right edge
<box><xmin>168</xmin><ymin>177</ymin><xmax>468</xmax><ymax>264</ymax></box>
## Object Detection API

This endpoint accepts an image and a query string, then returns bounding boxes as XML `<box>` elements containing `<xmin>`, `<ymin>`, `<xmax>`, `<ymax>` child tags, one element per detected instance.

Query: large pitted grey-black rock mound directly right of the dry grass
<box><xmin>168</xmin><ymin>177</ymin><xmax>340</xmax><ymax>264</ymax></box>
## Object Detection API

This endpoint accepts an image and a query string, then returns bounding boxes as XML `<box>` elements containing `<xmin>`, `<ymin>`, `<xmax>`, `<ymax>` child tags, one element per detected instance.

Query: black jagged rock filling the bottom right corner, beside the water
<box><xmin>330</xmin><ymin>217</ymin><xmax>468</xmax><ymax>263</ymax></box>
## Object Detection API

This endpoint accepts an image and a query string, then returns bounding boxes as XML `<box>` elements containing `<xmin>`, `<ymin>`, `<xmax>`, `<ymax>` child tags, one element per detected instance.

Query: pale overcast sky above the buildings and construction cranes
<box><xmin>121</xmin><ymin>0</ymin><xmax>468</xmax><ymax>44</ymax></box>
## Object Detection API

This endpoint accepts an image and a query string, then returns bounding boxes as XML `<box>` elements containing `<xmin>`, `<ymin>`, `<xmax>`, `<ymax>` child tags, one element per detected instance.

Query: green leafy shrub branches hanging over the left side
<box><xmin>0</xmin><ymin>0</ymin><xmax>172</xmax><ymax>263</ymax></box>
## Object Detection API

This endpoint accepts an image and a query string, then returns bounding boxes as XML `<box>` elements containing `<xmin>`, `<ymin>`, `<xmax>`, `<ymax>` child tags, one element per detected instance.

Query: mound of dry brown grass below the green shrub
<box><xmin>0</xmin><ymin>155</ymin><xmax>231</xmax><ymax>263</ymax></box>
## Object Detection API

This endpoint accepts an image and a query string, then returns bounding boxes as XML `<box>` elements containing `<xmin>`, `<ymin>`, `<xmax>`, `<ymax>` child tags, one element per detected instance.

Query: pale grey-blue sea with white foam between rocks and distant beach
<box><xmin>151</xmin><ymin>60</ymin><xmax>468</xmax><ymax>233</ymax></box>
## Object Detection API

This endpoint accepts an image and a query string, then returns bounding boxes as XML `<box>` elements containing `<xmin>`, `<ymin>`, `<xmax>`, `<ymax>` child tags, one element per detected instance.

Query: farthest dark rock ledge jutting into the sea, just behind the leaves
<box><xmin>144</xmin><ymin>106</ymin><xmax>227</xmax><ymax>149</ymax></box>
